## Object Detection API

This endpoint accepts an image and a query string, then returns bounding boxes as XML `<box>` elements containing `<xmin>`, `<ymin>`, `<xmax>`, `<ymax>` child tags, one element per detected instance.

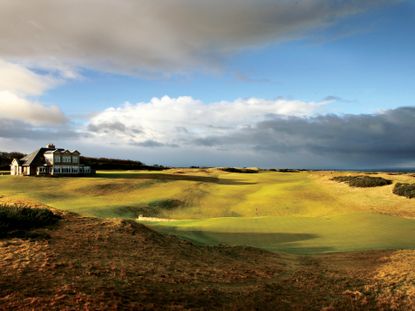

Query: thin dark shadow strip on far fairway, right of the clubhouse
<box><xmin>94</xmin><ymin>173</ymin><xmax>255</xmax><ymax>185</ymax></box>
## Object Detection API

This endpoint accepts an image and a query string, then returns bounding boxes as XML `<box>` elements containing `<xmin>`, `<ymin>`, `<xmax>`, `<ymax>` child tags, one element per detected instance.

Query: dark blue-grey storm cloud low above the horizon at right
<box><xmin>193</xmin><ymin>107</ymin><xmax>415</xmax><ymax>166</ymax></box>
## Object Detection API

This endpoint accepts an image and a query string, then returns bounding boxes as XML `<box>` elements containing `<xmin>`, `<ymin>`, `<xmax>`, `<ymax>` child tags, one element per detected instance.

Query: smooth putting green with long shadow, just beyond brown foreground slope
<box><xmin>146</xmin><ymin>213</ymin><xmax>415</xmax><ymax>254</ymax></box>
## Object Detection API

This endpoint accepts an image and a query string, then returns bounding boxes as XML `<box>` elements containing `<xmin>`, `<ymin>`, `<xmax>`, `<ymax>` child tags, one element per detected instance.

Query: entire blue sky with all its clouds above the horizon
<box><xmin>0</xmin><ymin>0</ymin><xmax>415</xmax><ymax>169</ymax></box>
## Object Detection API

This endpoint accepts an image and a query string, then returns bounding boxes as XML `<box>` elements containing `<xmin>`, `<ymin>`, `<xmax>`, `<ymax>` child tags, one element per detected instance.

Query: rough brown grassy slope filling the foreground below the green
<box><xmin>0</xmin><ymin>206</ymin><xmax>415</xmax><ymax>310</ymax></box>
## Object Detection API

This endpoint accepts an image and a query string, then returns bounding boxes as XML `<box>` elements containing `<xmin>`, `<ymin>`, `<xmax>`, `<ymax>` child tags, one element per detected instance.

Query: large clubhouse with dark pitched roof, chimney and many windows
<box><xmin>10</xmin><ymin>144</ymin><xmax>93</xmax><ymax>176</ymax></box>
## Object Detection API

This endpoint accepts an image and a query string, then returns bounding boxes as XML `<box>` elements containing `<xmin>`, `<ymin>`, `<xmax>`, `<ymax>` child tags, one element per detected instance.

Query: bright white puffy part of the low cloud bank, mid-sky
<box><xmin>88</xmin><ymin>96</ymin><xmax>327</xmax><ymax>147</ymax></box>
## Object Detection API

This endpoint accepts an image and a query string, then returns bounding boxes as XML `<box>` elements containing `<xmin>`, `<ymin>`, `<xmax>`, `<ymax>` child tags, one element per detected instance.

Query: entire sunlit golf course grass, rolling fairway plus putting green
<box><xmin>0</xmin><ymin>169</ymin><xmax>415</xmax><ymax>253</ymax></box>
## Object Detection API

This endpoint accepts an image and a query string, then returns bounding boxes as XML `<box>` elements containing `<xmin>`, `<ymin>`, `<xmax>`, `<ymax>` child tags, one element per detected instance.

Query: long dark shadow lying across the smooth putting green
<box><xmin>151</xmin><ymin>226</ymin><xmax>334</xmax><ymax>254</ymax></box>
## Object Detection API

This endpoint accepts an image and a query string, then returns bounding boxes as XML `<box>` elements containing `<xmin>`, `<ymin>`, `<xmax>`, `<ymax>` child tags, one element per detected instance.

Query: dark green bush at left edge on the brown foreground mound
<box><xmin>0</xmin><ymin>205</ymin><xmax>61</xmax><ymax>238</ymax></box>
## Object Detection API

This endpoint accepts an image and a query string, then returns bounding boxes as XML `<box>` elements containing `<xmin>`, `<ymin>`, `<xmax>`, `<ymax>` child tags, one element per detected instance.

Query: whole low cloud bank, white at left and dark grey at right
<box><xmin>89</xmin><ymin>102</ymin><xmax>415</xmax><ymax>168</ymax></box>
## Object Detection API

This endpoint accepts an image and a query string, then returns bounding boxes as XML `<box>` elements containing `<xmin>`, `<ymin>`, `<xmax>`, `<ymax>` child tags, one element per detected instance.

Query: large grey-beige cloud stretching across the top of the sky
<box><xmin>0</xmin><ymin>0</ymin><xmax>396</xmax><ymax>76</ymax></box>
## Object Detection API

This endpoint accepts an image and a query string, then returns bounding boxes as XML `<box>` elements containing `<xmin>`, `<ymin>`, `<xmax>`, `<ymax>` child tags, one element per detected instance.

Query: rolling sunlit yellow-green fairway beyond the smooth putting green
<box><xmin>0</xmin><ymin>169</ymin><xmax>415</xmax><ymax>219</ymax></box>
